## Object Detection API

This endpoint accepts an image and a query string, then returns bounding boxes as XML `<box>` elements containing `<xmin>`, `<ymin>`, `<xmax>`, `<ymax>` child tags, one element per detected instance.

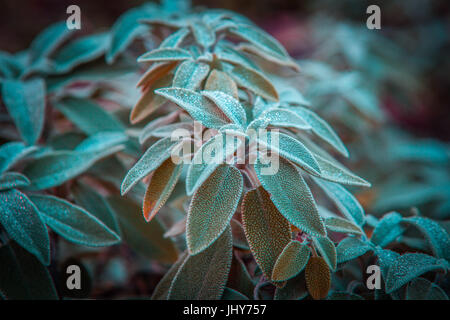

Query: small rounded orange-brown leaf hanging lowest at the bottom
<box><xmin>305</xmin><ymin>257</ymin><xmax>331</xmax><ymax>300</ymax></box>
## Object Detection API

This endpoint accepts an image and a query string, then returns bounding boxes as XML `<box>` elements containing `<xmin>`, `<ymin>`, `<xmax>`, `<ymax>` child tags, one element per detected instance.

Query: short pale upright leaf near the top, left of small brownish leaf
<box><xmin>172</xmin><ymin>60</ymin><xmax>209</xmax><ymax>90</ymax></box>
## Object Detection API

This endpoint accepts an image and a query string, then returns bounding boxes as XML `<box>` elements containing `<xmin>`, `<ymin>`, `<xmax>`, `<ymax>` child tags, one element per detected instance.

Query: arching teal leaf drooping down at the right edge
<box><xmin>403</xmin><ymin>217</ymin><xmax>450</xmax><ymax>261</ymax></box>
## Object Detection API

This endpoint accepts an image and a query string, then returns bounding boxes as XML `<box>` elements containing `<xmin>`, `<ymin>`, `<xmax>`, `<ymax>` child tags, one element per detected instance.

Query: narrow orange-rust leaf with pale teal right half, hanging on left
<box><xmin>143</xmin><ymin>158</ymin><xmax>183</xmax><ymax>221</ymax></box>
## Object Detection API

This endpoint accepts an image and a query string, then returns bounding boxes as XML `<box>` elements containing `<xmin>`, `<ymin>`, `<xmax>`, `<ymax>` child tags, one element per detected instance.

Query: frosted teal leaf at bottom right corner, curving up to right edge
<box><xmin>385</xmin><ymin>253</ymin><xmax>449</xmax><ymax>293</ymax></box>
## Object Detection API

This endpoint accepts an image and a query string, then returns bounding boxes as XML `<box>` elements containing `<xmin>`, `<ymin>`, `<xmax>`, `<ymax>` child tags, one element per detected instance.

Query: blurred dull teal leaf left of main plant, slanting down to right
<box><xmin>54</xmin><ymin>98</ymin><xmax>124</xmax><ymax>135</ymax></box>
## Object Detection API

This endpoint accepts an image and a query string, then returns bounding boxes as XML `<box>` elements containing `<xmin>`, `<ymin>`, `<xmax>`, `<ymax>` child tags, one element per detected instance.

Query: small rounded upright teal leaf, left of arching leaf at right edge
<box><xmin>370</xmin><ymin>212</ymin><xmax>405</xmax><ymax>247</ymax></box>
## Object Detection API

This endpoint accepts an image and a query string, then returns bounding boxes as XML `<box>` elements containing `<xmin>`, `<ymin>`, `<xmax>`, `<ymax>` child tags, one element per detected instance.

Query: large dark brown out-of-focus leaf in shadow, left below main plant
<box><xmin>108</xmin><ymin>196</ymin><xmax>178</xmax><ymax>263</ymax></box>
